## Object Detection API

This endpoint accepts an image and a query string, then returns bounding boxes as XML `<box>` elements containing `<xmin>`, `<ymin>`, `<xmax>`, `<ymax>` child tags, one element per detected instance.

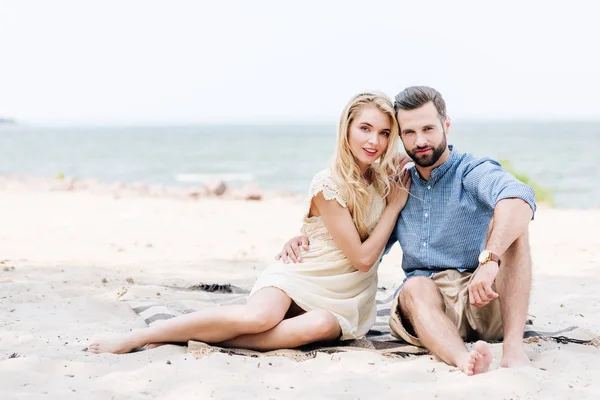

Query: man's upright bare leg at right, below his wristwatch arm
<box><xmin>496</xmin><ymin>233</ymin><xmax>531</xmax><ymax>367</ymax></box>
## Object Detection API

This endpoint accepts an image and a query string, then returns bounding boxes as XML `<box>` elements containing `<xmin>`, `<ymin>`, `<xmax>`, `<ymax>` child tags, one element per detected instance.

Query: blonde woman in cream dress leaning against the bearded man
<box><xmin>89</xmin><ymin>94</ymin><xmax>410</xmax><ymax>354</ymax></box>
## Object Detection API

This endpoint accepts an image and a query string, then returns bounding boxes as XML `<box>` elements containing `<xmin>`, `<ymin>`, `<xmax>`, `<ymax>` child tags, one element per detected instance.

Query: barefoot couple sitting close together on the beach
<box><xmin>89</xmin><ymin>86</ymin><xmax>535</xmax><ymax>375</ymax></box>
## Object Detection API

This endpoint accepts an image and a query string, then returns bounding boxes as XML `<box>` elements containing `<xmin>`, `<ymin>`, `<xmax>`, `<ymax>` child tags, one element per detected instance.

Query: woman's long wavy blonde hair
<box><xmin>330</xmin><ymin>93</ymin><xmax>400</xmax><ymax>241</ymax></box>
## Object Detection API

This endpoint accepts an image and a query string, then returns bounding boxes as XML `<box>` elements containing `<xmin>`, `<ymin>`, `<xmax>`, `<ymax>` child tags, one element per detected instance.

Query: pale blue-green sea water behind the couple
<box><xmin>0</xmin><ymin>121</ymin><xmax>600</xmax><ymax>208</ymax></box>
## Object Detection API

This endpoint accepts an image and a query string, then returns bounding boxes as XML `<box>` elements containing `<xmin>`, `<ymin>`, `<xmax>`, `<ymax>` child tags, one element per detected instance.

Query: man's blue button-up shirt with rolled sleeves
<box><xmin>384</xmin><ymin>146</ymin><xmax>536</xmax><ymax>278</ymax></box>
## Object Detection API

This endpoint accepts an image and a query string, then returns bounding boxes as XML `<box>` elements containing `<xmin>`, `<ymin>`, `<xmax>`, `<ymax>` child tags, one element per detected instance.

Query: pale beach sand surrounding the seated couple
<box><xmin>0</xmin><ymin>182</ymin><xmax>600</xmax><ymax>400</ymax></box>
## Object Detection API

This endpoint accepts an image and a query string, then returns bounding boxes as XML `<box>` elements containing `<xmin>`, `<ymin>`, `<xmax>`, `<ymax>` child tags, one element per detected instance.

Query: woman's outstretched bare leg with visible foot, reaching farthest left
<box><xmin>88</xmin><ymin>287</ymin><xmax>292</xmax><ymax>354</ymax></box>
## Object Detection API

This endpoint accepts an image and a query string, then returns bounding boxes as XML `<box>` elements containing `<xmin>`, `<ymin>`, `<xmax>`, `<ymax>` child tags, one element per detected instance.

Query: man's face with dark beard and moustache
<box><xmin>398</xmin><ymin>102</ymin><xmax>450</xmax><ymax>168</ymax></box>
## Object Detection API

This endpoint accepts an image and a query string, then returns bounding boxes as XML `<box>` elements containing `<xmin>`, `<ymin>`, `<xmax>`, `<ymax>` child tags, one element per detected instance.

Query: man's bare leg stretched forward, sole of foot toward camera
<box><xmin>399</xmin><ymin>276</ymin><xmax>492</xmax><ymax>375</ymax></box>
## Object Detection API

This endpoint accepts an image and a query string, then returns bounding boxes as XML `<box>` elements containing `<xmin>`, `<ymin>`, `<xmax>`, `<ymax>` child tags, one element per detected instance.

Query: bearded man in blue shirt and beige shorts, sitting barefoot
<box><xmin>277</xmin><ymin>86</ymin><xmax>536</xmax><ymax>375</ymax></box>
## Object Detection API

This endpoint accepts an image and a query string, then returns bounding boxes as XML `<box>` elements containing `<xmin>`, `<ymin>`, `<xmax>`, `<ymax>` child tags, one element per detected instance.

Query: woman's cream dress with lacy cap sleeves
<box><xmin>250</xmin><ymin>170</ymin><xmax>385</xmax><ymax>340</ymax></box>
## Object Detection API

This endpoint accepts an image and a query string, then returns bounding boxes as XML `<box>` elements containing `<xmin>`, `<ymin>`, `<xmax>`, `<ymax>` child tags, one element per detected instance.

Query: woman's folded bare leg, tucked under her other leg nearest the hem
<box><xmin>219</xmin><ymin>310</ymin><xmax>341</xmax><ymax>351</ymax></box>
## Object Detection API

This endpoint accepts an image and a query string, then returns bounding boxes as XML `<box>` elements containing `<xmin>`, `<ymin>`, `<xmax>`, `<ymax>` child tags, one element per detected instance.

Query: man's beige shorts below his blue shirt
<box><xmin>390</xmin><ymin>269</ymin><xmax>503</xmax><ymax>347</ymax></box>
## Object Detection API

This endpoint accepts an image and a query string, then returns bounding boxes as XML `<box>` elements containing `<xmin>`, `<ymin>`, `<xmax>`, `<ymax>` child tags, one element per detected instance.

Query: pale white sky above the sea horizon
<box><xmin>0</xmin><ymin>0</ymin><xmax>600</xmax><ymax>125</ymax></box>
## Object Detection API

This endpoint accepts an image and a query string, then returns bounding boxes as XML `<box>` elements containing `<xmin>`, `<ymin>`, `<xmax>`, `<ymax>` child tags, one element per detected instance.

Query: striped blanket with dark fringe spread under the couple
<box><xmin>123</xmin><ymin>284</ymin><xmax>600</xmax><ymax>361</ymax></box>
